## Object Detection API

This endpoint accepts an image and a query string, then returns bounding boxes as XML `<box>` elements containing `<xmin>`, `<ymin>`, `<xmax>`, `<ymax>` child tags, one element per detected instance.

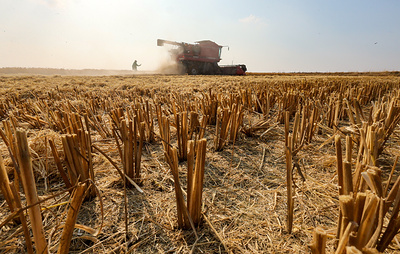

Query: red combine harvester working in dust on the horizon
<box><xmin>157</xmin><ymin>39</ymin><xmax>247</xmax><ymax>75</ymax></box>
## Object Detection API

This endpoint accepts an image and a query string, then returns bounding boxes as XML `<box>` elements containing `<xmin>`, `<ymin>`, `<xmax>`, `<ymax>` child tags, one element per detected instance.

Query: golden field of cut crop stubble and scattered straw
<box><xmin>0</xmin><ymin>73</ymin><xmax>400</xmax><ymax>253</ymax></box>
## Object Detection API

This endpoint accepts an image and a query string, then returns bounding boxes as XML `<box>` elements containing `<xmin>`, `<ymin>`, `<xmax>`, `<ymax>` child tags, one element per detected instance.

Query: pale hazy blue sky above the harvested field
<box><xmin>0</xmin><ymin>0</ymin><xmax>400</xmax><ymax>72</ymax></box>
